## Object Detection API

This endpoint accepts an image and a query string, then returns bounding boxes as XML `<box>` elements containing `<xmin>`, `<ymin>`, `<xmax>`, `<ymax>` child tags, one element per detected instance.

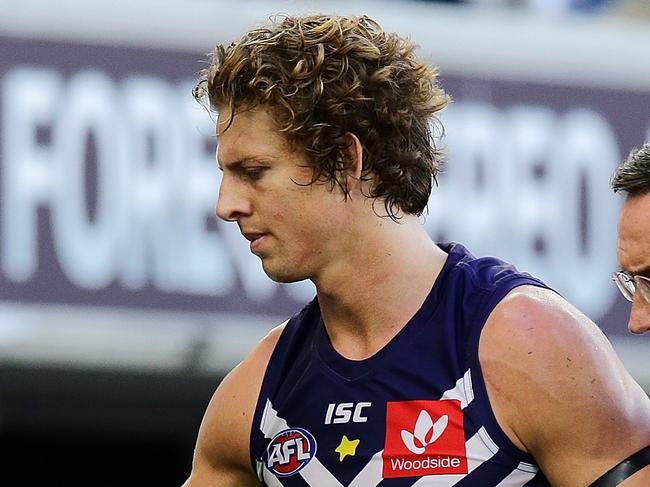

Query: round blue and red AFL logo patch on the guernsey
<box><xmin>264</xmin><ymin>428</ymin><xmax>316</xmax><ymax>477</ymax></box>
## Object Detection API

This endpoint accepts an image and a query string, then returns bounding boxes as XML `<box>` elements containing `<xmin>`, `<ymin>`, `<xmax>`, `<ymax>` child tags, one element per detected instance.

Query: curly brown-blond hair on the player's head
<box><xmin>194</xmin><ymin>15</ymin><xmax>449</xmax><ymax>218</ymax></box>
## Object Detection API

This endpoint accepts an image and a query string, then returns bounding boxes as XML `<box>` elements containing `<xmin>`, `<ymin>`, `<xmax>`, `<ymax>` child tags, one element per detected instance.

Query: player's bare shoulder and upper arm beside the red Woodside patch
<box><xmin>479</xmin><ymin>286</ymin><xmax>650</xmax><ymax>486</ymax></box>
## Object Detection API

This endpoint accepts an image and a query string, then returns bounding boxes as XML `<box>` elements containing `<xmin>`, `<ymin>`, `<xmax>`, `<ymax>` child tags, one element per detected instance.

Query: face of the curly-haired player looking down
<box><xmin>217</xmin><ymin>108</ymin><xmax>350</xmax><ymax>282</ymax></box>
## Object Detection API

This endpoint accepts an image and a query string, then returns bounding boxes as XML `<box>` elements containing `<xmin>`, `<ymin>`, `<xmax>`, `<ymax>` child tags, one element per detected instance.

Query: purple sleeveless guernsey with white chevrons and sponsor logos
<box><xmin>250</xmin><ymin>244</ymin><xmax>549</xmax><ymax>487</ymax></box>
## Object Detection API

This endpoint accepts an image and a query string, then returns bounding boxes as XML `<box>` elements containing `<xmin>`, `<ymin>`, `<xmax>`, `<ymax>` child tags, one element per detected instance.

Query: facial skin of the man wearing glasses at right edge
<box><xmin>617</xmin><ymin>193</ymin><xmax>650</xmax><ymax>333</ymax></box>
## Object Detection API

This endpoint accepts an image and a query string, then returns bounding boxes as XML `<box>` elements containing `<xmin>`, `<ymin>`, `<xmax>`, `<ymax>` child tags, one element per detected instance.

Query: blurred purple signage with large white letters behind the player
<box><xmin>0</xmin><ymin>2</ymin><xmax>650</xmax><ymax>382</ymax></box>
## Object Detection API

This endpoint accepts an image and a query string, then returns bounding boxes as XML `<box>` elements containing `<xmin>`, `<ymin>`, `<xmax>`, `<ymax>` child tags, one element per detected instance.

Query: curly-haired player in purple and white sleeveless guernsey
<box><xmin>185</xmin><ymin>15</ymin><xmax>650</xmax><ymax>487</ymax></box>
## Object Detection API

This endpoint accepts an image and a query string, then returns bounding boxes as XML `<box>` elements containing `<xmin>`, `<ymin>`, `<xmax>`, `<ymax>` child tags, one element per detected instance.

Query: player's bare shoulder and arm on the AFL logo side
<box><xmin>185</xmin><ymin>322</ymin><xmax>287</xmax><ymax>487</ymax></box>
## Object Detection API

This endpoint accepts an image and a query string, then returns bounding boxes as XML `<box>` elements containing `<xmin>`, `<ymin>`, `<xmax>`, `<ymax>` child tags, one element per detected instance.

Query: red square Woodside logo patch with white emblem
<box><xmin>382</xmin><ymin>400</ymin><xmax>467</xmax><ymax>478</ymax></box>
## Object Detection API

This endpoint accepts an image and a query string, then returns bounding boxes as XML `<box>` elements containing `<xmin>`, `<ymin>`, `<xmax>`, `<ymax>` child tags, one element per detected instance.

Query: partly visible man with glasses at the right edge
<box><xmin>612</xmin><ymin>143</ymin><xmax>650</xmax><ymax>333</ymax></box>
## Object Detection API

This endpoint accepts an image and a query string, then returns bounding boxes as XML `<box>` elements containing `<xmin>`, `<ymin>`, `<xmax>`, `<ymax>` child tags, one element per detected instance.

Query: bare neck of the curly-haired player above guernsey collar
<box><xmin>314</xmin><ymin>216</ymin><xmax>447</xmax><ymax>360</ymax></box>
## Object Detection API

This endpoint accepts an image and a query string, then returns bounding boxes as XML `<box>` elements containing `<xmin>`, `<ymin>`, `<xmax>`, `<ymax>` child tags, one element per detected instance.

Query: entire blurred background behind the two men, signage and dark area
<box><xmin>0</xmin><ymin>0</ymin><xmax>650</xmax><ymax>487</ymax></box>
